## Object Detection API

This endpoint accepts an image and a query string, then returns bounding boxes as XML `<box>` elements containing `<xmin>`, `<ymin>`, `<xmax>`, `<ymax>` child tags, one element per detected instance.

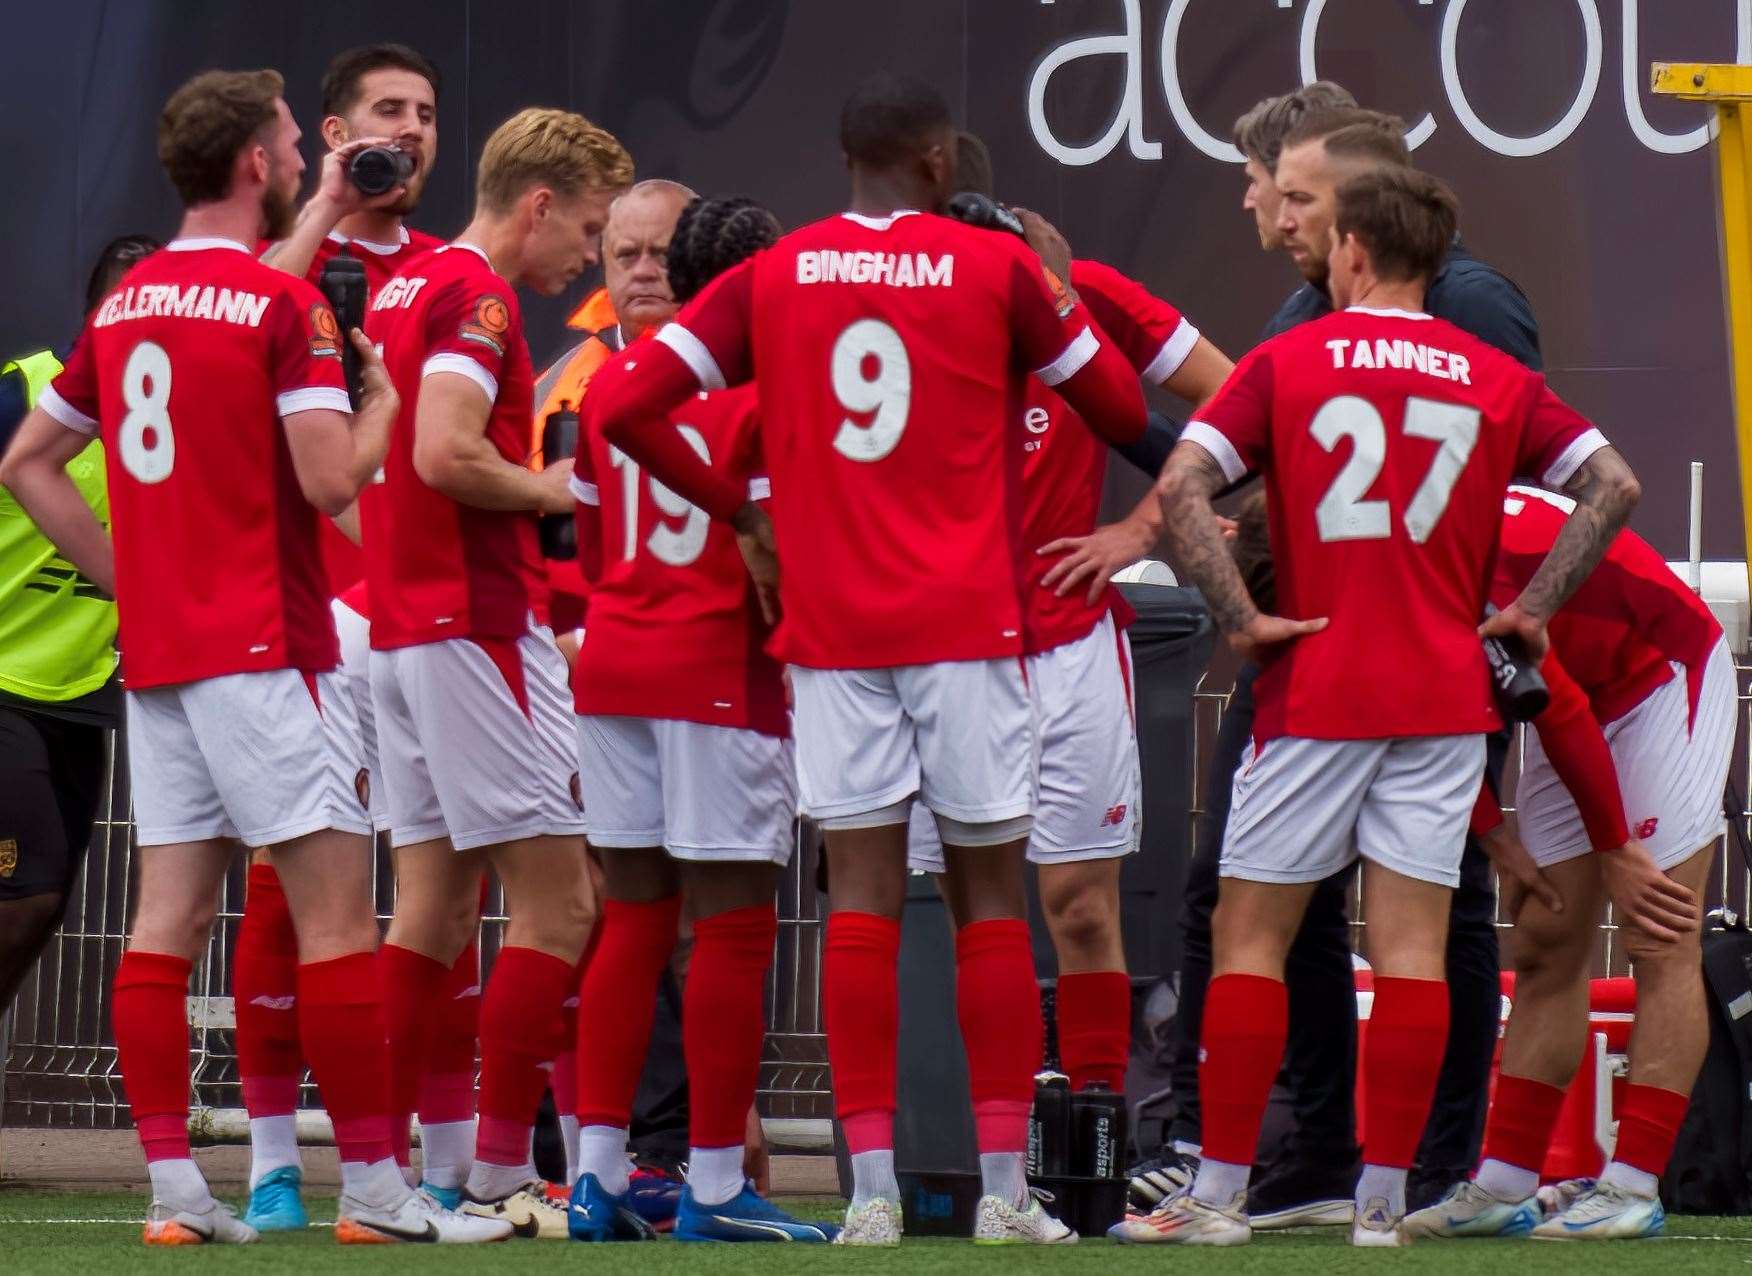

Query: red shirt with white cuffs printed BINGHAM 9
<box><xmin>657</xmin><ymin>212</ymin><xmax>1099</xmax><ymax>670</ymax></box>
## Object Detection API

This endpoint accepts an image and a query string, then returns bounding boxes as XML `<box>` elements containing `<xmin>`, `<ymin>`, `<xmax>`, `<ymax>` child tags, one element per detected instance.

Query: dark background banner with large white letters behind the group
<box><xmin>0</xmin><ymin>0</ymin><xmax>1752</xmax><ymax>557</ymax></box>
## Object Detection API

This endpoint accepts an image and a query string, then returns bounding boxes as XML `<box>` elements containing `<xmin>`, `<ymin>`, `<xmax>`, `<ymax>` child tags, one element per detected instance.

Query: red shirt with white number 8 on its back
<box><xmin>40</xmin><ymin>238</ymin><xmax>350</xmax><ymax>689</ymax></box>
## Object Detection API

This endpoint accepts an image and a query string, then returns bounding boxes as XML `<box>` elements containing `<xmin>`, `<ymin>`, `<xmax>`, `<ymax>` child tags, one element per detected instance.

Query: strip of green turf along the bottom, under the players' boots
<box><xmin>0</xmin><ymin>1188</ymin><xmax>1752</xmax><ymax>1276</ymax></box>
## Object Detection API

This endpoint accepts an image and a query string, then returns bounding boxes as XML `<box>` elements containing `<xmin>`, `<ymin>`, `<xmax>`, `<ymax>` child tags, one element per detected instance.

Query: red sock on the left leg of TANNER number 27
<box><xmin>1198</xmin><ymin>975</ymin><xmax>1289</xmax><ymax>1166</ymax></box>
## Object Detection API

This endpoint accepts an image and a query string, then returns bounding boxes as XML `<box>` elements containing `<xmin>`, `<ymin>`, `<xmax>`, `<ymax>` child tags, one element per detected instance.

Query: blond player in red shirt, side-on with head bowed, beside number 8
<box><xmin>361</xmin><ymin>109</ymin><xmax>632</xmax><ymax>1237</ymax></box>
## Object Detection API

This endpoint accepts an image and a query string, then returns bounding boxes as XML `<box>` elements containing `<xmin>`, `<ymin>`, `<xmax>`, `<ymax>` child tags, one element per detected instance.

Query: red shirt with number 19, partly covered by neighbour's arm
<box><xmin>573</xmin><ymin>354</ymin><xmax>790</xmax><ymax>736</ymax></box>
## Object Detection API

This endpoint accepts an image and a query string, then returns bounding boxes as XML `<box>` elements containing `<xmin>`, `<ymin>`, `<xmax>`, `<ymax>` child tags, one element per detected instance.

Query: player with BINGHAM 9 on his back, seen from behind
<box><xmin>594</xmin><ymin>75</ymin><xmax>1144</xmax><ymax>1244</ymax></box>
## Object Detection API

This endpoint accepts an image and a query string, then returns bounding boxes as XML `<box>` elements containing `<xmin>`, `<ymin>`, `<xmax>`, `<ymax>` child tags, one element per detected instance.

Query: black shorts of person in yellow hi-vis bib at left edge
<box><xmin>0</xmin><ymin>705</ymin><xmax>105</xmax><ymax>901</ymax></box>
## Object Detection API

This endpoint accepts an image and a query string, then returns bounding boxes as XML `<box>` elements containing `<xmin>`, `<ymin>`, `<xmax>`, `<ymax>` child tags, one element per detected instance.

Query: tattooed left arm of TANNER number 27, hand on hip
<box><xmin>1156</xmin><ymin>440</ymin><xmax>1326</xmax><ymax>657</ymax></box>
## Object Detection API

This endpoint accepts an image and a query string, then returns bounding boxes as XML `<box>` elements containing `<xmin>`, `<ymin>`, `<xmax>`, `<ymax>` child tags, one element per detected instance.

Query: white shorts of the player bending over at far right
<box><xmin>1515</xmin><ymin>638</ymin><xmax>1740</xmax><ymax>869</ymax></box>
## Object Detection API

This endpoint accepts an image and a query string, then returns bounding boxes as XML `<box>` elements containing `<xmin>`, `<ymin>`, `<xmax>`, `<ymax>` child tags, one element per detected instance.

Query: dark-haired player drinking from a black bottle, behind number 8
<box><xmin>231</xmin><ymin>44</ymin><xmax>480</xmax><ymax>1232</ymax></box>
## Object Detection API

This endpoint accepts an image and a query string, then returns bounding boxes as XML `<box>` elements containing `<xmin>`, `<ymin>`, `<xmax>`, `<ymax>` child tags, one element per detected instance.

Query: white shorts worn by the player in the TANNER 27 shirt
<box><xmin>1218</xmin><ymin>734</ymin><xmax>1484</xmax><ymax>887</ymax></box>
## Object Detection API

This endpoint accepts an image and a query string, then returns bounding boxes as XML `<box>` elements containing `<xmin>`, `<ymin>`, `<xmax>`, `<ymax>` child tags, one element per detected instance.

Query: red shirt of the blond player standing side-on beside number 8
<box><xmin>359</xmin><ymin>244</ymin><xmax>541</xmax><ymax>650</ymax></box>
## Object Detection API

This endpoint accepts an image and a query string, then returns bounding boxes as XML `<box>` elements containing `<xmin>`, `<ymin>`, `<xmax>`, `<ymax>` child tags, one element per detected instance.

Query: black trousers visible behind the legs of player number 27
<box><xmin>1169</xmin><ymin>664</ymin><xmax>1507</xmax><ymax>1178</ymax></box>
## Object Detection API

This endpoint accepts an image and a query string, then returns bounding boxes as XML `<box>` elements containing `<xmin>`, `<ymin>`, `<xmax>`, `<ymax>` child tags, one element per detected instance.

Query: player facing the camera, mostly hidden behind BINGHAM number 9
<box><xmin>908</xmin><ymin>133</ymin><xmax>1233</xmax><ymax>1090</ymax></box>
